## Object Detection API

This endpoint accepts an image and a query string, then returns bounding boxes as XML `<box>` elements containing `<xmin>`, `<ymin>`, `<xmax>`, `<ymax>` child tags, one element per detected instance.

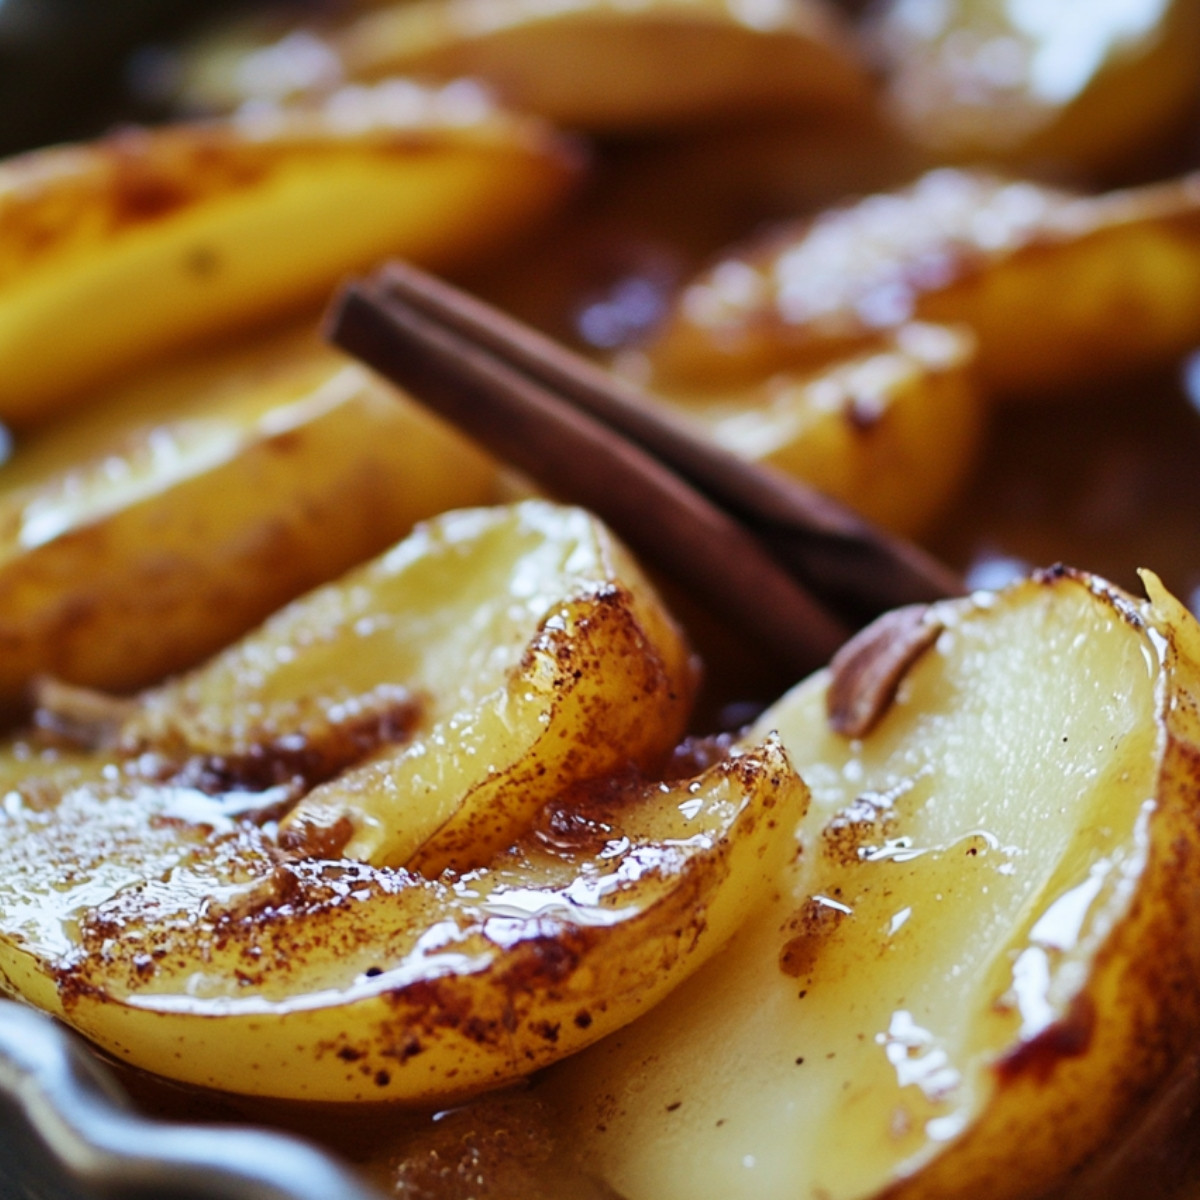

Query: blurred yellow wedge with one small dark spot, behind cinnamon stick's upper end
<box><xmin>0</xmin><ymin>80</ymin><xmax>576</xmax><ymax>425</ymax></box>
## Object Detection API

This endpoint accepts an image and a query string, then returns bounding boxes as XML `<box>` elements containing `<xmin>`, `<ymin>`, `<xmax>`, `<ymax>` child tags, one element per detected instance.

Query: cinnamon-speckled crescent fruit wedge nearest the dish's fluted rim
<box><xmin>0</xmin><ymin>724</ymin><xmax>806</xmax><ymax>1104</ymax></box>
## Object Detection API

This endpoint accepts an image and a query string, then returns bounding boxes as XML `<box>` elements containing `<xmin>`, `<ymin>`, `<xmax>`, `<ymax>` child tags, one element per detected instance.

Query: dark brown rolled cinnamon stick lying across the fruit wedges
<box><xmin>328</xmin><ymin>264</ymin><xmax>959</xmax><ymax>672</ymax></box>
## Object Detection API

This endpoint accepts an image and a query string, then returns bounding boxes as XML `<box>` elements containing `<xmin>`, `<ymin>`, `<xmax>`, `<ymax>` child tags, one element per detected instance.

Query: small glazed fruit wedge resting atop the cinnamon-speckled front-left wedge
<box><xmin>118</xmin><ymin>500</ymin><xmax>694</xmax><ymax>875</ymax></box>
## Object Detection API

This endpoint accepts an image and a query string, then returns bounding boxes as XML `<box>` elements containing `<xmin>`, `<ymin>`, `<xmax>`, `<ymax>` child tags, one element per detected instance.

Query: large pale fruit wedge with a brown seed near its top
<box><xmin>553</xmin><ymin>570</ymin><xmax>1200</xmax><ymax>1200</ymax></box>
